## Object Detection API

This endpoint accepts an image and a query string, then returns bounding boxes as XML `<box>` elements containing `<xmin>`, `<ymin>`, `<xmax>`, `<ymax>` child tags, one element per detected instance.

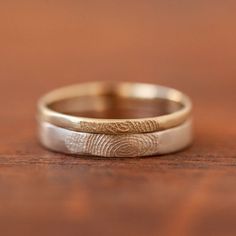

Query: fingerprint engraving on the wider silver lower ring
<box><xmin>65</xmin><ymin>132</ymin><xmax>159</xmax><ymax>157</ymax></box>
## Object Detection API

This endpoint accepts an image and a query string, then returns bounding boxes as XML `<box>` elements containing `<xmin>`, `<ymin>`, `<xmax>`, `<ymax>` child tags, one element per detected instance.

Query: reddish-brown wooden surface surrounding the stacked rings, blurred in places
<box><xmin>0</xmin><ymin>0</ymin><xmax>236</xmax><ymax>236</ymax></box>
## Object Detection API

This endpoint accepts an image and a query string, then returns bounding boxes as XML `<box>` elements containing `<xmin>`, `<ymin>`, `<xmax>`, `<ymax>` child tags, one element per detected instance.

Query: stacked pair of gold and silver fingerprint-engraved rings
<box><xmin>37</xmin><ymin>82</ymin><xmax>193</xmax><ymax>157</ymax></box>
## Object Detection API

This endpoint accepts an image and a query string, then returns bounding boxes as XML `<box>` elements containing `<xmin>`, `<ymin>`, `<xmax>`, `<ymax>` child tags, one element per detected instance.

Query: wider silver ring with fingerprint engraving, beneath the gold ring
<box><xmin>39</xmin><ymin>119</ymin><xmax>193</xmax><ymax>157</ymax></box>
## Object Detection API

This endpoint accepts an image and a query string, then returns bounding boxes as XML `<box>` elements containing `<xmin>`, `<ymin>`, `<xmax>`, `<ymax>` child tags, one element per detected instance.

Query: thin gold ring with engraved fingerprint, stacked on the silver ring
<box><xmin>38</xmin><ymin>82</ymin><xmax>192</xmax><ymax>135</ymax></box>
